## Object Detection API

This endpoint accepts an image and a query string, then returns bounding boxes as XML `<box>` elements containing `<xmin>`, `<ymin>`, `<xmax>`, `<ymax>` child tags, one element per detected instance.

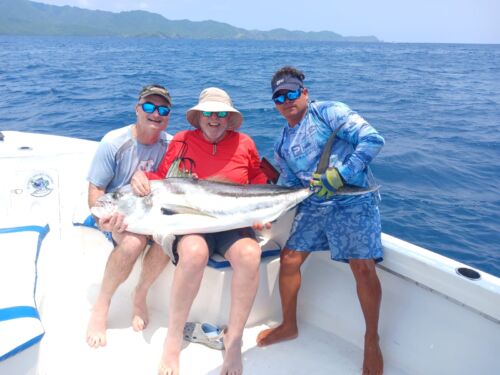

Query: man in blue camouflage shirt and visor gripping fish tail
<box><xmin>257</xmin><ymin>66</ymin><xmax>384</xmax><ymax>375</ymax></box>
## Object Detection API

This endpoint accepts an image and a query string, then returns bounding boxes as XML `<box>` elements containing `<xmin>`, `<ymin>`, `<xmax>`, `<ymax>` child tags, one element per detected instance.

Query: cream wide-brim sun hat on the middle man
<box><xmin>186</xmin><ymin>87</ymin><xmax>243</xmax><ymax>130</ymax></box>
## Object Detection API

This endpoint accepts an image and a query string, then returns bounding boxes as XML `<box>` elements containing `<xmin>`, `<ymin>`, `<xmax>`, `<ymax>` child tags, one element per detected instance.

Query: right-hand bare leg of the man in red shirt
<box><xmin>221</xmin><ymin>238</ymin><xmax>261</xmax><ymax>375</ymax></box>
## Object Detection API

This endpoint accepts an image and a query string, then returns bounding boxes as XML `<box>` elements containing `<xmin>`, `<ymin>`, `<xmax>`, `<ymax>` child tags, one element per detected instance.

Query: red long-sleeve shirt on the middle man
<box><xmin>146</xmin><ymin>129</ymin><xmax>267</xmax><ymax>184</ymax></box>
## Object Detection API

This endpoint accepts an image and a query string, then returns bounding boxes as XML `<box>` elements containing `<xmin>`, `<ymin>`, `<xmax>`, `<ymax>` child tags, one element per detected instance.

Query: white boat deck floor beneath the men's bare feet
<box><xmin>38</xmin><ymin>305</ymin><xmax>402</xmax><ymax>375</ymax></box>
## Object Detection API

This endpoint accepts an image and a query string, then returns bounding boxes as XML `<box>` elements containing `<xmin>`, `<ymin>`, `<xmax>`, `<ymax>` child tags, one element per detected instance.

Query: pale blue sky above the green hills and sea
<box><xmin>37</xmin><ymin>0</ymin><xmax>500</xmax><ymax>44</ymax></box>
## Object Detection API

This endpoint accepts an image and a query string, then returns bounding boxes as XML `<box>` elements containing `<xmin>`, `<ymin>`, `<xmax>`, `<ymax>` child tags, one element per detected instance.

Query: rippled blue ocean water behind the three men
<box><xmin>0</xmin><ymin>37</ymin><xmax>500</xmax><ymax>276</ymax></box>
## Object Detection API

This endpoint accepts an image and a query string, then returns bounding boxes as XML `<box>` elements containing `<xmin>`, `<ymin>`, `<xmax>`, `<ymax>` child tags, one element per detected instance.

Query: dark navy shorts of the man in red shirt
<box><xmin>172</xmin><ymin>227</ymin><xmax>257</xmax><ymax>264</ymax></box>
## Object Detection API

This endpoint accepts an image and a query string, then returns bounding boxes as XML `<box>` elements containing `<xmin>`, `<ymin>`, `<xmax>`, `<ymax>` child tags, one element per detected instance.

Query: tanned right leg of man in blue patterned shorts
<box><xmin>349</xmin><ymin>259</ymin><xmax>384</xmax><ymax>375</ymax></box>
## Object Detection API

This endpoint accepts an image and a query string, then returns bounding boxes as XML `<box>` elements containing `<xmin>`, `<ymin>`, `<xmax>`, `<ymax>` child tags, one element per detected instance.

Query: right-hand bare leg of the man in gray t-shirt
<box><xmin>132</xmin><ymin>243</ymin><xmax>170</xmax><ymax>331</ymax></box>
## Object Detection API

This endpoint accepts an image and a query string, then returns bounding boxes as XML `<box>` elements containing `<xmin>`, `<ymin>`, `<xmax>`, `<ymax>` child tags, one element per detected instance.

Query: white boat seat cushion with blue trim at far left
<box><xmin>0</xmin><ymin>225</ymin><xmax>49</xmax><ymax>361</ymax></box>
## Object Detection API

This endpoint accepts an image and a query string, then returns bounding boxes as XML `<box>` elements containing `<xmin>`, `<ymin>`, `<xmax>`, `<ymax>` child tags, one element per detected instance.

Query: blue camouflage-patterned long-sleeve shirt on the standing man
<box><xmin>274</xmin><ymin>101</ymin><xmax>384</xmax><ymax>204</ymax></box>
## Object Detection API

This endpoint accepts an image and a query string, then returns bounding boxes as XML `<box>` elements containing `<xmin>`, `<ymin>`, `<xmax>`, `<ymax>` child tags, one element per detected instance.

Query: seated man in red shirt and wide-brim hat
<box><xmin>132</xmin><ymin>87</ymin><xmax>267</xmax><ymax>374</ymax></box>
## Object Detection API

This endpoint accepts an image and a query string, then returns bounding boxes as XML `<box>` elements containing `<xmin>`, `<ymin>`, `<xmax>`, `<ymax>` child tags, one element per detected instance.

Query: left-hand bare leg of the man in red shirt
<box><xmin>159</xmin><ymin>234</ymin><xmax>208</xmax><ymax>375</ymax></box>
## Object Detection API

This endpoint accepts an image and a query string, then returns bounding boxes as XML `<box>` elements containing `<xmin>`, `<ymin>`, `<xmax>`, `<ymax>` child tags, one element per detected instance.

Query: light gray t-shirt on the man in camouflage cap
<box><xmin>87</xmin><ymin>125</ymin><xmax>172</xmax><ymax>193</ymax></box>
